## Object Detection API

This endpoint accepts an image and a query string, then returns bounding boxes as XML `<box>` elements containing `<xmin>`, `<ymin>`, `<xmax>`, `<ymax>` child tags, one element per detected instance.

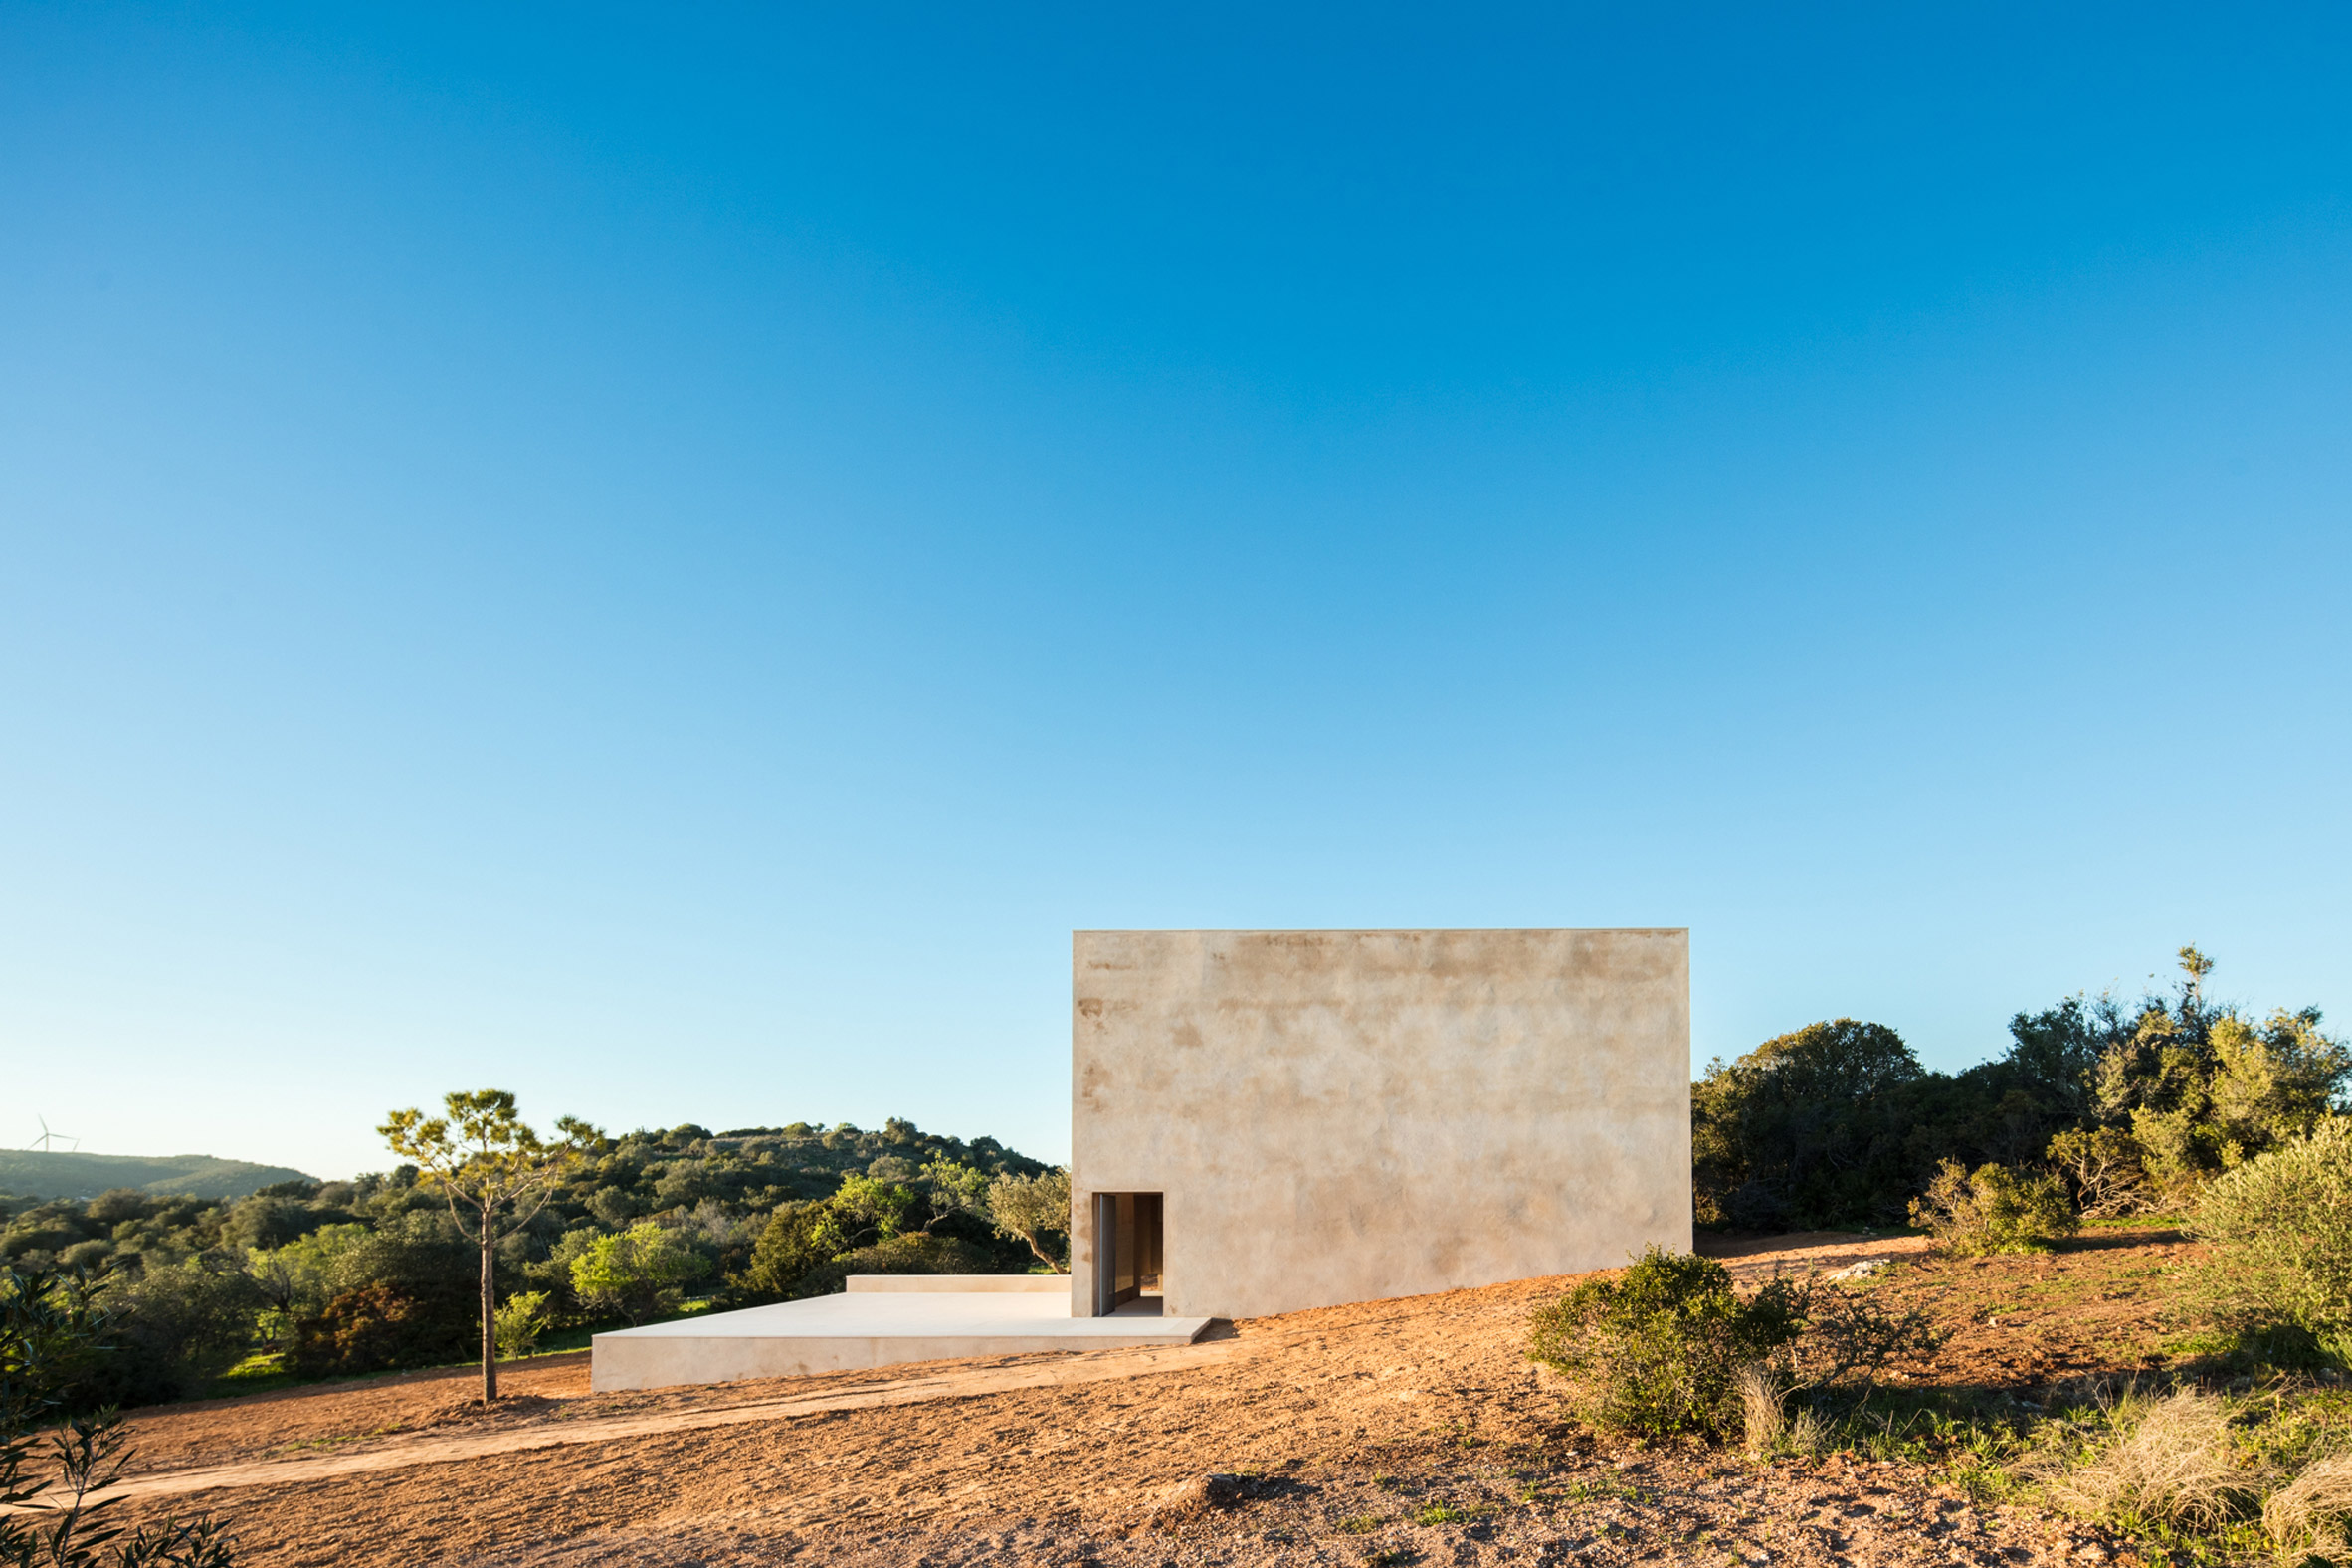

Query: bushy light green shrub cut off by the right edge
<box><xmin>2190</xmin><ymin>1116</ymin><xmax>2352</xmax><ymax>1349</ymax></box>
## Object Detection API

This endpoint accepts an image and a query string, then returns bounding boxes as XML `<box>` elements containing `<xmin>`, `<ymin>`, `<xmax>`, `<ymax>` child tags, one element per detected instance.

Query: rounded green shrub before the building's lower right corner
<box><xmin>1526</xmin><ymin>1246</ymin><xmax>1804</xmax><ymax>1437</ymax></box>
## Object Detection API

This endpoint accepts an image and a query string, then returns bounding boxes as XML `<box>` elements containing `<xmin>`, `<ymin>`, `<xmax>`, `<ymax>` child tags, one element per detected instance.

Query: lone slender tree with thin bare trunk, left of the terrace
<box><xmin>376</xmin><ymin>1088</ymin><xmax>602</xmax><ymax>1404</ymax></box>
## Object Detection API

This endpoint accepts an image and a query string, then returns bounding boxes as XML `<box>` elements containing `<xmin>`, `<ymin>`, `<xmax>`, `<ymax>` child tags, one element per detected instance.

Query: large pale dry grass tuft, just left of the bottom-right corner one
<box><xmin>2049</xmin><ymin>1389</ymin><xmax>2260</xmax><ymax>1528</ymax></box>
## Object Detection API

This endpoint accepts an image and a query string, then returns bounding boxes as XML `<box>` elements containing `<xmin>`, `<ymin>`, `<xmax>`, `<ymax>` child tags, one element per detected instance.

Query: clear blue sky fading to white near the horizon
<box><xmin>0</xmin><ymin>2</ymin><xmax>2352</xmax><ymax>1175</ymax></box>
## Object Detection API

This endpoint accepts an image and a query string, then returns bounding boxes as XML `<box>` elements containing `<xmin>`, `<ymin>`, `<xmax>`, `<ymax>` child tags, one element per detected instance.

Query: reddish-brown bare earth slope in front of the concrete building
<box><xmin>92</xmin><ymin>1230</ymin><xmax>2185</xmax><ymax>1568</ymax></box>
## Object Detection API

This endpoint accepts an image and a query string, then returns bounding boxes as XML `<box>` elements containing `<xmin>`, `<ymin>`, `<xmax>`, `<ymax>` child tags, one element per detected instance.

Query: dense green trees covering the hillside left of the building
<box><xmin>0</xmin><ymin>1119</ymin><xmax>1059</xmax><ymax>1404</ymax></box>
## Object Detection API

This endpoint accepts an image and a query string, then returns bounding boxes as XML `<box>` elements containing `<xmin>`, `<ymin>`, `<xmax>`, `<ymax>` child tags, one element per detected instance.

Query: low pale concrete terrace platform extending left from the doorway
<box><xmin>588</xmin><ymin>1274</ymin><xmax>1209</xmax><ymax>1394</ymax></box>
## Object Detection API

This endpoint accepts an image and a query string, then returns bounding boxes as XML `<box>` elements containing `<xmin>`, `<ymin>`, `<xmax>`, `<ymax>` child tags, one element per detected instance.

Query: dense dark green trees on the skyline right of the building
<box><xmin>1691</xmin><ymin>947</ymin><xmax>2352</xmax><ymax>1230</ymax></box>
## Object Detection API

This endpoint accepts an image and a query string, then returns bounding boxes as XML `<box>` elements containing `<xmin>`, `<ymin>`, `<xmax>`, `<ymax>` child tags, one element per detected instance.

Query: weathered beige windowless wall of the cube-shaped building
<box><xmin>1071</xmin><ymin>931</ymin><xmax>1691</xmax><ymax>1319</ymax></box>
